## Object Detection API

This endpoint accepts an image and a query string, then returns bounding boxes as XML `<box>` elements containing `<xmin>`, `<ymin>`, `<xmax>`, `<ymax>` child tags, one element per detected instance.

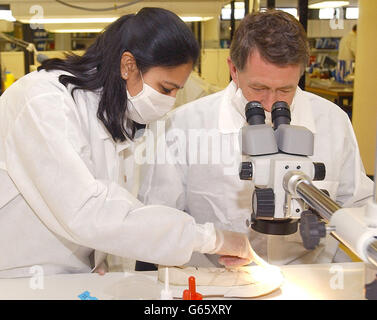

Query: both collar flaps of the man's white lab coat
<box><xmin>218</xmin><ymin>81</ymin><xmax>316</xmax><ymax>134</ymax></box>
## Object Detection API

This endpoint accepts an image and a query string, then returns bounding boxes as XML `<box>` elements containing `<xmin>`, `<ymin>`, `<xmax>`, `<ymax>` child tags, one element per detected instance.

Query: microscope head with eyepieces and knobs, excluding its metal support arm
<box><xmin>240</xmin><ymin>102</ymin><xmax>325</xmax><ymax>235</ymax></box>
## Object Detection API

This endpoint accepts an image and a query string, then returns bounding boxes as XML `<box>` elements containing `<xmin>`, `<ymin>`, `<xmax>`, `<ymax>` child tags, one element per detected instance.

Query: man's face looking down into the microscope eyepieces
<box><xmin>228</xmin><ymin>50</ymin><xmax>301</xmax><ymax>112</ymax></box>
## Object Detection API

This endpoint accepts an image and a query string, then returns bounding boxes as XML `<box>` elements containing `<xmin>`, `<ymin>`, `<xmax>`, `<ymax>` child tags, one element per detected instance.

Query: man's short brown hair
<box><xmin>230</xmin><ymin>10</ymin><xmax>309</xmax><ymax>71</ymax></box>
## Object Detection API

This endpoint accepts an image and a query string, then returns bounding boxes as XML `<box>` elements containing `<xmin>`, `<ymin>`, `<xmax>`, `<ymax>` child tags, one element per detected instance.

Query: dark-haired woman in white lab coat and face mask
<box><xmin>0</xmin><ymin>8</ymin><xmax>252</xmax><ymax>277</ymax></box>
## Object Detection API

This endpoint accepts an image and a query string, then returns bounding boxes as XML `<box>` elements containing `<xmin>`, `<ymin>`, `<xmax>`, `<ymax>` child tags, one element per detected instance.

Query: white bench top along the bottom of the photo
<box><xmin>0</xmin><ymin>262</ymin><xmax>365</xmax><ymax>300</ymax></box>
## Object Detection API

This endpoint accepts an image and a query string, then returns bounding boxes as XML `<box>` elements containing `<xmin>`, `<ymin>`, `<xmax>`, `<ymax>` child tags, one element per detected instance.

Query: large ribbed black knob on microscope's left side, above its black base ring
<box><xmin>253</xmin><ymin>188</ymin><xmax>275</xmax><ymax>219</ymax></box>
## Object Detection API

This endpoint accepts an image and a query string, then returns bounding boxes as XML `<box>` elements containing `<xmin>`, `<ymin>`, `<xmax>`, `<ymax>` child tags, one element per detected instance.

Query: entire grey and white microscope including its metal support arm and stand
<box><xmin>239</xmin><ymin>101</ymin><xmax>377</xmax><ymax>299</ymax></box>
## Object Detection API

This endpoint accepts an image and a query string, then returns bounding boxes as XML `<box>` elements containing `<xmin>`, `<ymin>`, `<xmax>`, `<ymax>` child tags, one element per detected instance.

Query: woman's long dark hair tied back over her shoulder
<box><xmin>38</xmin><ymin>8</ymin><xmax>199</xmax><ymax>141</ymax></box>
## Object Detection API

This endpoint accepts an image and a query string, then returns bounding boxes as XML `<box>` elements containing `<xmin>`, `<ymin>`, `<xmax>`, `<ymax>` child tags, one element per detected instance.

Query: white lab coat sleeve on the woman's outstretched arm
<box><xmin>5</xmin><ymin>94</ymin><xmax>215</xmax><ymax>265</ymax></box>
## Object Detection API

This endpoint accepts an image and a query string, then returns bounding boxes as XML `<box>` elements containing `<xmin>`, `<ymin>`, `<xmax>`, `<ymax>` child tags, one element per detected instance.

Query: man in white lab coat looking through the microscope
<box><xmin>139</xmin><ymin>11</ymin><xmax>373</xmax><ymax>266</ymax></box>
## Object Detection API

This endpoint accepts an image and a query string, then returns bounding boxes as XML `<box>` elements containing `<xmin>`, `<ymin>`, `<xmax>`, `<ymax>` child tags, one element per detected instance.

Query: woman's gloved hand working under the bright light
<box><xmin>211</xmin><ymin>229</ymin><xmax>267</xmax><ymax>267</ymax></box>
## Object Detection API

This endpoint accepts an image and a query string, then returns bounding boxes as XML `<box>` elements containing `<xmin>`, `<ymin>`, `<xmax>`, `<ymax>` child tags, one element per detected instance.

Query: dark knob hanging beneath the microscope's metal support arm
<box><xmin>300</xmin><ymin>211</ymin><xmax>326</xmax><ymax>250</ymax></box>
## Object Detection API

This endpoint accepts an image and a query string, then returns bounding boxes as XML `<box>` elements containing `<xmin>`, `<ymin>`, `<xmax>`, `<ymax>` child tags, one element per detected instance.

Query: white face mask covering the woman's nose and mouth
<box><xmin>127</xmin><ymin>77</ymin><xmax>176</xmax><ymax>124</ymax></box>
